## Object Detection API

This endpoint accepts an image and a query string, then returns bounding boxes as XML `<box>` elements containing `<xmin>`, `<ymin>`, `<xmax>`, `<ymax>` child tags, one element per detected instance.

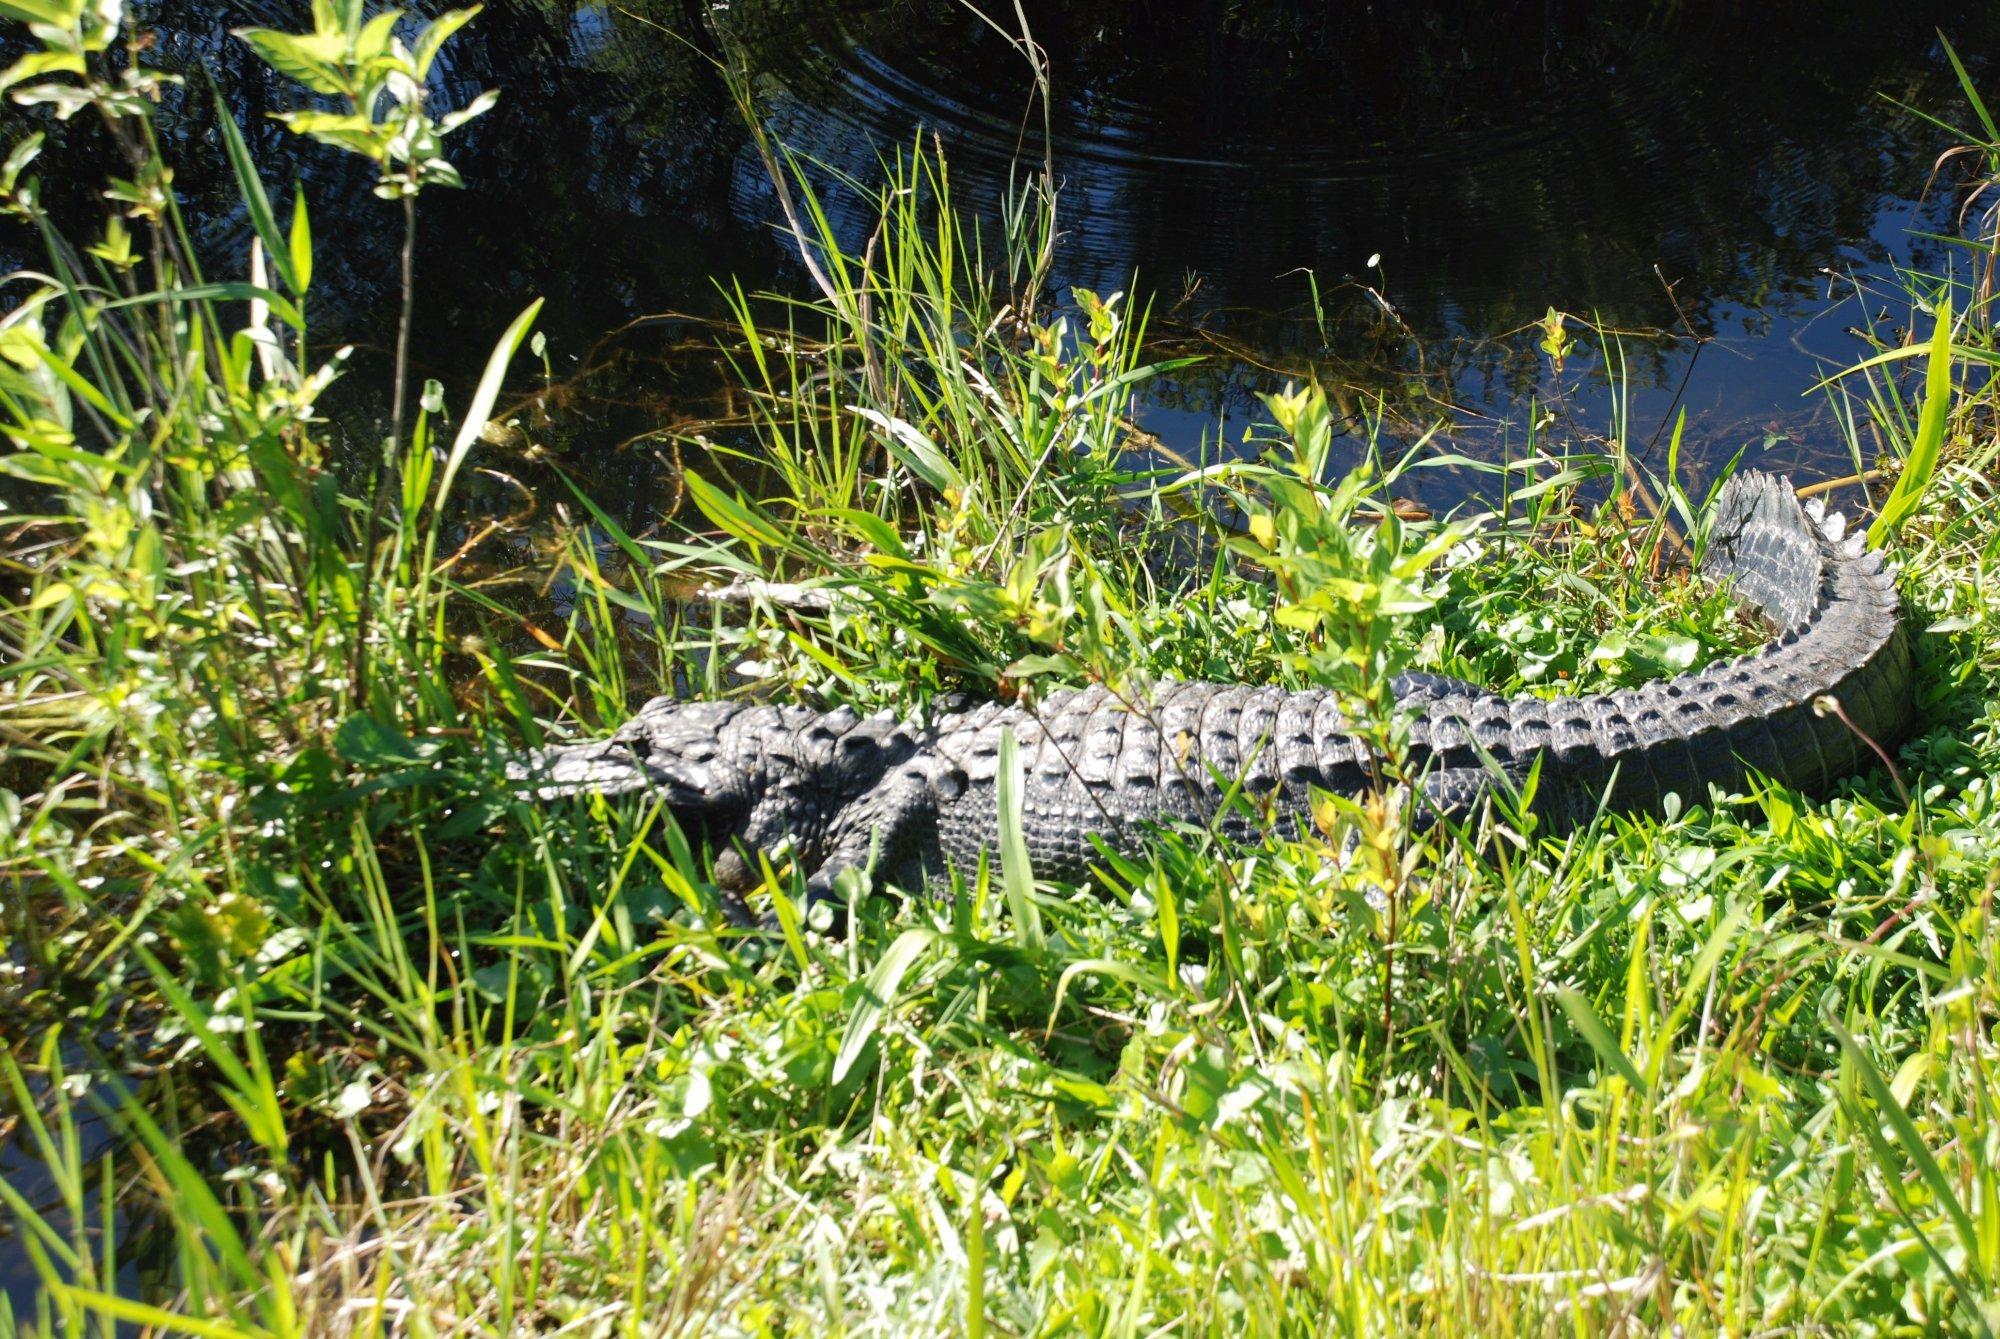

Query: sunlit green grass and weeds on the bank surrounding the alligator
<box><xmin>0</xmin><ymin>6</ymin><xmax>2000</xmax><ymax>1335</ymax></box>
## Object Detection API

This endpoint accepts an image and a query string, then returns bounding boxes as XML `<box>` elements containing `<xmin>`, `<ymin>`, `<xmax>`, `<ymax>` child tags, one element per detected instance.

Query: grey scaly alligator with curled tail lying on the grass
<box><xmin>516</xmin><ymin>472</ymin><xmax>1914</xmax><ymax>899</ymax></box>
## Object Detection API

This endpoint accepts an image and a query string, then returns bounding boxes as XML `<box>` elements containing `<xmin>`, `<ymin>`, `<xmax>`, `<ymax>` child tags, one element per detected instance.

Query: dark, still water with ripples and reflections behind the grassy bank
<box><xmin>11</xmin><ymin>0</ymin><xmax>2000</xmax><ymax>524</ymax></box>
